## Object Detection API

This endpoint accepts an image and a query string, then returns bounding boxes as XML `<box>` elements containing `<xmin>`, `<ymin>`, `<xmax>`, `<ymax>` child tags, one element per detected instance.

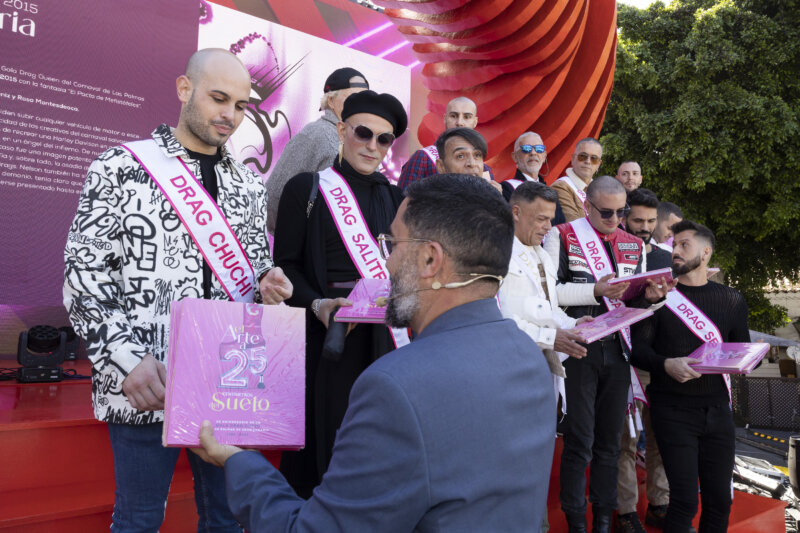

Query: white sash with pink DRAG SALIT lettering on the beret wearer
<box><xmin>319</xmin><ymin>168</ymin><xmax>411</xmax><ymax>348</ymax></box>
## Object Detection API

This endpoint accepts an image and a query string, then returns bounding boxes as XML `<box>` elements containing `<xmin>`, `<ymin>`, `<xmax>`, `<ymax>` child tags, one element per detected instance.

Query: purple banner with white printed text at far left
<box><xmin>0</xmin><ymin>0</ymin><xmax>198</xmax><ymax>353</ymax></box>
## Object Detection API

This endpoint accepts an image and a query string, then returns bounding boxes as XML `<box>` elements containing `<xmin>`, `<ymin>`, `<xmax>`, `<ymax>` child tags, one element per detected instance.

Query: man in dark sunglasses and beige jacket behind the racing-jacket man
<box><xmin>552</xmin><ymin>137</ymin><xmax>603</xmax><ymax>222</ymax></box>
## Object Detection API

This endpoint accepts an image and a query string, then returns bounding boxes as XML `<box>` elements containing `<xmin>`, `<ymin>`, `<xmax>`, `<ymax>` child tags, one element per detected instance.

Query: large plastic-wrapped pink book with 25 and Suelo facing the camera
<box><xmin>162</xmin><ymin>298</ymin><xmax>305</xmax><ymax>449</ymax></box>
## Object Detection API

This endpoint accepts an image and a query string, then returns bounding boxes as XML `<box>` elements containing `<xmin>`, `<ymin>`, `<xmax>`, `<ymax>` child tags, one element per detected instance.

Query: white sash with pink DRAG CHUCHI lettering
<box><xmin>122</xmin><ymin>139</ymin><xmax>255</xmax><ymax>303</ymax></box>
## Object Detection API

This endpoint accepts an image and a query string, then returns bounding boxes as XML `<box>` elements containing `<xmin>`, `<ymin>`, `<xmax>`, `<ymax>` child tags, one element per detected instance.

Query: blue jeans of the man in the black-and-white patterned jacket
<box><xmin>108</xmin><ymin>423</ymin><xmax>242</xmax><ymax>533</ymax></box>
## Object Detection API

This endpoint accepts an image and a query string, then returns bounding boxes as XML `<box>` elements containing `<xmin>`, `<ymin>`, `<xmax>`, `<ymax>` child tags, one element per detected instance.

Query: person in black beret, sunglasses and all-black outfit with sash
<box><xmin>274</xmin><ymin>90</ymin><xmax>408</xmax><ymax>497</ymax></box>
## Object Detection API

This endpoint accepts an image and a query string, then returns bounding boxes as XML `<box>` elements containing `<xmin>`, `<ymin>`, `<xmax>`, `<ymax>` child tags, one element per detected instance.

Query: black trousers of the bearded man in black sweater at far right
<box><xmin>650</xmin><ymin>397</ymin><xmax>736</xmax><ymax>533</ymax></box>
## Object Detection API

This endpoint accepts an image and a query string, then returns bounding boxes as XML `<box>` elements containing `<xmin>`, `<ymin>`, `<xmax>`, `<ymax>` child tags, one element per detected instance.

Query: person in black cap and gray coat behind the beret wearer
<box><xmin>267</xmin><ymin>67</ymin><xmax>369</xmax><ymax>234</ymax></box>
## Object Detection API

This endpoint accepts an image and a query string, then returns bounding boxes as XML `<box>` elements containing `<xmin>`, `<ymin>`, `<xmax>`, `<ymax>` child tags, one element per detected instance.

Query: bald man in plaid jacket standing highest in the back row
<box><xmin>397</xmin><ymin>96</ymin><xmax>494</xmax><ymax>189</ymax></box>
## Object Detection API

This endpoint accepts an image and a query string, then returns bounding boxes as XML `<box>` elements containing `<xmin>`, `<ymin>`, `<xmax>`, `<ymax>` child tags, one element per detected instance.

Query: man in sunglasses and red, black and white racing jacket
<box><xmin>545</xmin><ymin>176</ymin><xmax>674</xmax><ymax>533</ymax></box>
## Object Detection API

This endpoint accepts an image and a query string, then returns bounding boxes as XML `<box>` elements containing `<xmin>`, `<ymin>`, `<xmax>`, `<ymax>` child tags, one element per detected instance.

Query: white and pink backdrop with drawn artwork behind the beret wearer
<box><xmin>198</xmin><ymin>4</ymin><xmax>411</xmax><ymax>179</ymax></box>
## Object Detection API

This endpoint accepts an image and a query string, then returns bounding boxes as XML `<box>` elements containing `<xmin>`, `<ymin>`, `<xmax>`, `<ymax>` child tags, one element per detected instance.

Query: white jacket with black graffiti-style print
<box><xmin>64</xmin><ymin>124</ymin><xmax>272</xmax><ymax>424</ymax></box>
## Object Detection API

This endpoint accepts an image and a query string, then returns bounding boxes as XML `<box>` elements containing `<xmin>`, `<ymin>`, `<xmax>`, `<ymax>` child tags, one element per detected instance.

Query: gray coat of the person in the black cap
<box><xmin>267</xmin><ymin>109</ymin><xmax>339</xmax><ymax>234</ymax></box>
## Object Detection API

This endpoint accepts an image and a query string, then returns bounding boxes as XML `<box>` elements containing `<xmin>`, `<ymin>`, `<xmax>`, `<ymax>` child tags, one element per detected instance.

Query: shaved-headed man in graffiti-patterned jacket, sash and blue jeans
<box><xmin>63</xmin><ymin>49</ymin><xmax>292</xmax><ymax>532</ymax></box>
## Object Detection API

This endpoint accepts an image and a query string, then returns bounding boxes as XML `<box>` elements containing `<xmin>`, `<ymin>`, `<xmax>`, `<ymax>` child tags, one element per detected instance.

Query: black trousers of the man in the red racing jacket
<box><xmin>561</xmin><ymin>339</ymin><xmax>631</xmax><ymax>515</ymax></box>
